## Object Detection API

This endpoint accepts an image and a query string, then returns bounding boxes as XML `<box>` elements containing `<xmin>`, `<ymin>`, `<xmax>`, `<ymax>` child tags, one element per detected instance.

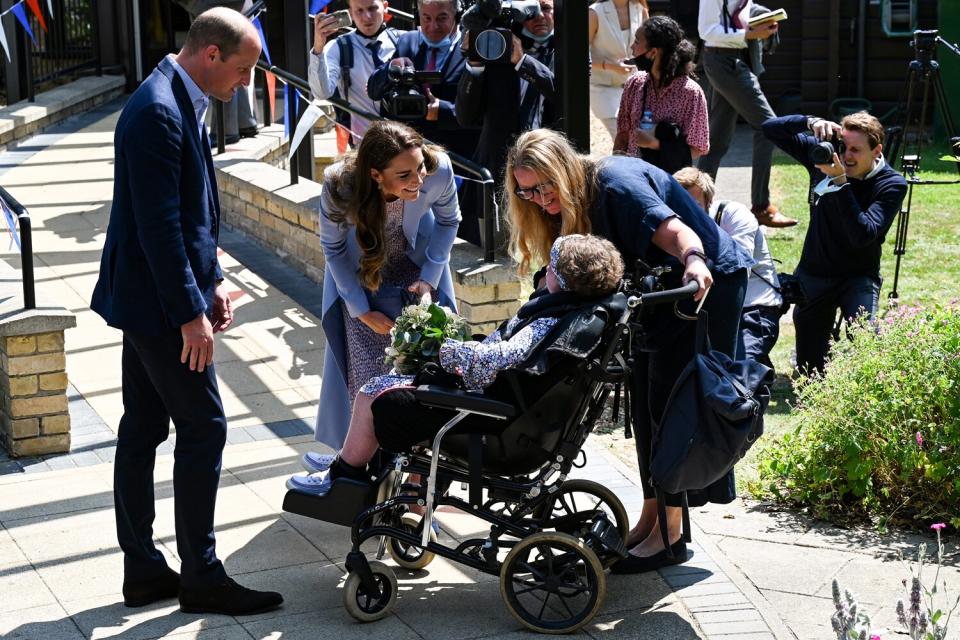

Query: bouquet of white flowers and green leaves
<box><xmin>385</xmin><ymin>296</ymin><xmax>470</xmax><ymax>375</ymax></box>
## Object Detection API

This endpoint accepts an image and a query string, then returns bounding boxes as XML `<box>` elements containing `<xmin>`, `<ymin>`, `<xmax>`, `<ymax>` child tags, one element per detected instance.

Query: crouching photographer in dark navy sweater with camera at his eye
<box><xmin>763</xmin><ymin>111</ymin><xmax>907</xmax><ymax>373</ymax></box>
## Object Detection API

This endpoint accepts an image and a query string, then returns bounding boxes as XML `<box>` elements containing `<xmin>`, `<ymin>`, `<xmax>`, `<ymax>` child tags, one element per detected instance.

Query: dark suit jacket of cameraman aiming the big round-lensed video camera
<box><xmin>456</xmin><ymin>38</ymin><xmax>559</xmax><ymax>244</ymax></box>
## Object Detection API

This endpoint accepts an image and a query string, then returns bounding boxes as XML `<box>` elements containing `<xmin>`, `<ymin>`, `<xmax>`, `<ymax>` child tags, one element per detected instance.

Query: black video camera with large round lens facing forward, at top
<box><xmin>461</xmin><ymin>0</ymin><xmax>540</xmax><ymax>64</ymax></box>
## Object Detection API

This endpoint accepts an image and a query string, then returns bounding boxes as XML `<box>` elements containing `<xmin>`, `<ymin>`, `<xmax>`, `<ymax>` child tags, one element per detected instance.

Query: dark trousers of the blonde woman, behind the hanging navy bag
<box><xmin>632</xmin><ymin>269</ymin><xmax>747</xmax><ymax>507</ymax></box>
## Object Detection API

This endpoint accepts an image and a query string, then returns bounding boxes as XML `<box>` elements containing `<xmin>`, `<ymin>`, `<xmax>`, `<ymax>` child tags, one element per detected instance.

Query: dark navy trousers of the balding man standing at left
<box><xmin>113</xmin><ymin>331</ymin><xmax>227</xmax><ymax>588</ymax></box>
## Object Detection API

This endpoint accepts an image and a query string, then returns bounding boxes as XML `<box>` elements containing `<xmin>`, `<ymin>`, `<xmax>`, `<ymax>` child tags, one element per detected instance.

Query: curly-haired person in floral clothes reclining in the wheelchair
<box><xmin>287</xmin><ymin>234</ymin><xmax>624</xmax><ymax>496</ymax></box>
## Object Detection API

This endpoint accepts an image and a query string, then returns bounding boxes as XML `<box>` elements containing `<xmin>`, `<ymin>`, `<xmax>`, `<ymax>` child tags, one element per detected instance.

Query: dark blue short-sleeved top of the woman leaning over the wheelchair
<box><xmin>590</xmin><ymin>156</ymin><xmax>754</xmax><ymax>274</ymax></box>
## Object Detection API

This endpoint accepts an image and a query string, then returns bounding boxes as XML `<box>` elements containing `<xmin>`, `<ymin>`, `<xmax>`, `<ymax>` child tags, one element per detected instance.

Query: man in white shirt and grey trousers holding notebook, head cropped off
<box><xmin>697</xmin><ymin>0</ymin><xmax>797</xmax><ymax>227</ymax></box>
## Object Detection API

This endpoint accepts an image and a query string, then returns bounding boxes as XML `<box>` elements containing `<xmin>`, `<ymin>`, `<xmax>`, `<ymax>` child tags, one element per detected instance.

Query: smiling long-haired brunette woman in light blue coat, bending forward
<box><xmin>316</xmin><ymin>121</ymin><xmax>460</xmax><ymax>449</ymax></box>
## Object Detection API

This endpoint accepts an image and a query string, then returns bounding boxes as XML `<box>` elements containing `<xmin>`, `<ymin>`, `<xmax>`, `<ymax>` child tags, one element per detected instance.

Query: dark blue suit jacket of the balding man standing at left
<box><xmin>90</xmin><ymin>58</ymin><xmax>222</xmax><ymax>335</ymax></box>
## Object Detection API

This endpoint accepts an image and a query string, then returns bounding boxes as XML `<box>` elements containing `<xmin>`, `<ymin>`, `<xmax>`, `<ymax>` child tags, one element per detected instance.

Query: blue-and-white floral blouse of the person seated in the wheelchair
<box><xmin>360</xmin><ymin>316</ymin><xmax>557</xmax><ymax>396</ymax></box>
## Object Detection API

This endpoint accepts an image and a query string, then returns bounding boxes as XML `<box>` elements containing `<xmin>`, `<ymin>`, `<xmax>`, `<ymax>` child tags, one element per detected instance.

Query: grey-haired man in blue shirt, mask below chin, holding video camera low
<box><xmin>367</xmin><ymin>0</ymin><xmax>479</xmax><ymax>157</ymax></box>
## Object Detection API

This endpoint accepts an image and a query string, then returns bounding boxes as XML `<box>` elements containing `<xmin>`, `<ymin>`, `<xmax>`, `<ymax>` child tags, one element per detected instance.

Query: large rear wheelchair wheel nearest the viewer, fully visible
<box><xmin>500</xmin><ymin>532</ymin><xmax>607</xmax><ymax>633</ymax></box>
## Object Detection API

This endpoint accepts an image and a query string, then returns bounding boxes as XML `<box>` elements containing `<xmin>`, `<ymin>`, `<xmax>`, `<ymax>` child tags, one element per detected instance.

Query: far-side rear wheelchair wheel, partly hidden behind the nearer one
<box><xmin>535</xmin><ymin>478</ymin><xmax>630</xmax><ymax>569</ymax></box>
